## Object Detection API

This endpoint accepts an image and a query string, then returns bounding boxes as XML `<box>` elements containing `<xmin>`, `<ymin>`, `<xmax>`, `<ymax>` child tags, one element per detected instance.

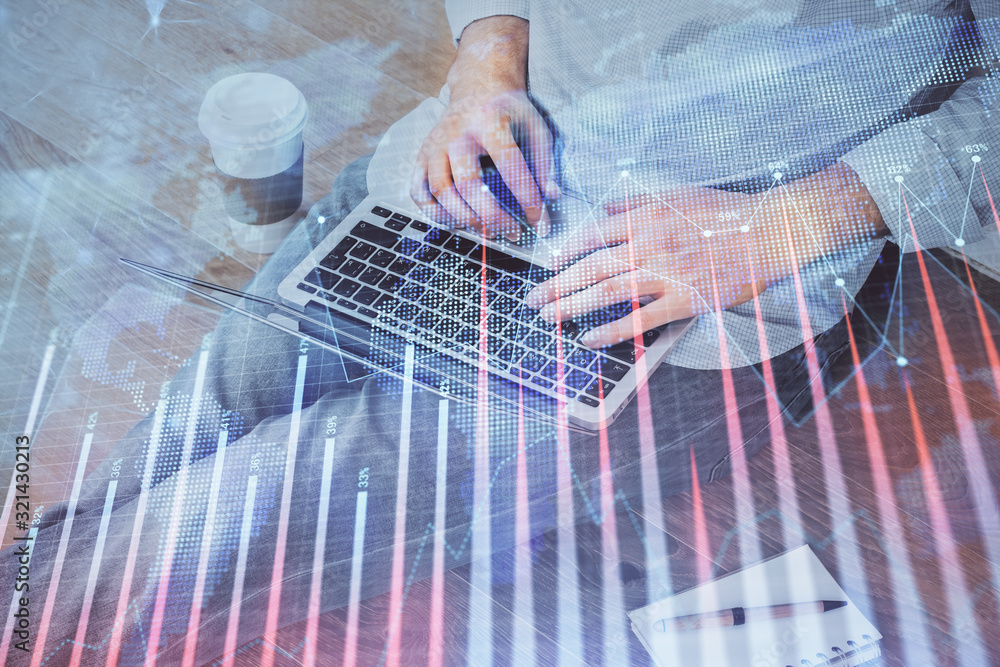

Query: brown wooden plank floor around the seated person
<box><xmin>0</xmin><ymin>0</ymin><xmax>1000</xmax><ymax>665</ymax></box>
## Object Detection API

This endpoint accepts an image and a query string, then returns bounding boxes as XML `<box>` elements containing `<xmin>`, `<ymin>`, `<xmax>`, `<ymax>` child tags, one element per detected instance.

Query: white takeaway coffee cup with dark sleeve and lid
<box><xmin>198</xmin><ymin>72</ymin><xmax>308</xmax><ymax>253</ymax></box>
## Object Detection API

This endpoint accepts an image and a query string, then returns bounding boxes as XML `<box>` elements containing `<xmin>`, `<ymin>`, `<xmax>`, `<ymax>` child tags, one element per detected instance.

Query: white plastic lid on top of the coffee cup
<box><xmin>198</xmin><ymin>72</ymin><xmax>309</xmax><ymax>147</ymax></box>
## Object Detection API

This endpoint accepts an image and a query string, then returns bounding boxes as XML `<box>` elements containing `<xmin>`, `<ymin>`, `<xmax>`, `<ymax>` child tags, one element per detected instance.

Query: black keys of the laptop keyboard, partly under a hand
<box><xmin>298</xmin><ymin>206</ymin><xmax>660</xmax><ymax>407</ymax></box>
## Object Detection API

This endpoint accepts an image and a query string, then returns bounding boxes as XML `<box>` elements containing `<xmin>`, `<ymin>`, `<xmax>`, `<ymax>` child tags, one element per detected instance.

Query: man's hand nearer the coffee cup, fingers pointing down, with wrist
<box><xmin>410</xmin><ymin>16</ymin><xmax>559</xmax><ymax>240</ymax></box>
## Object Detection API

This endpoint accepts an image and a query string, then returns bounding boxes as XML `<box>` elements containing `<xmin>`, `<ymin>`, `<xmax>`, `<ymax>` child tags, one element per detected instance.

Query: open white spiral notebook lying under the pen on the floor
<box><xmin>629</xmin><ymin>545</ymin><xmax>882</xmax><ymax>667</ymax></box>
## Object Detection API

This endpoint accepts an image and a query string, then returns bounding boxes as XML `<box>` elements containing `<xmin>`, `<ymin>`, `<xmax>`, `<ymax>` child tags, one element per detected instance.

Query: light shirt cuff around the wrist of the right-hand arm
<box><xmin>841</xmin><ymin>118</ymin><xmax>983</xmax><ymax>252</ymax></box>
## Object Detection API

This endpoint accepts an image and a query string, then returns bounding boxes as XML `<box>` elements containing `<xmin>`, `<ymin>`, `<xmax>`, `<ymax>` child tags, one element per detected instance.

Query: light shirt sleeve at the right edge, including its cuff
<box><xmin>842</xmin><ymin>0</ymin><xmax>1000</xmax><ymax>250</ymax></box>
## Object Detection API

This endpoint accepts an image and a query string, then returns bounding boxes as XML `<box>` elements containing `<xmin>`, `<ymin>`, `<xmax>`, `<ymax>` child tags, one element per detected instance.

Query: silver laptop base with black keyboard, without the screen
<box><xmin>278</xmin><ymin>161</ymin><xmax>690</xmax><ymax>430</ymax></box>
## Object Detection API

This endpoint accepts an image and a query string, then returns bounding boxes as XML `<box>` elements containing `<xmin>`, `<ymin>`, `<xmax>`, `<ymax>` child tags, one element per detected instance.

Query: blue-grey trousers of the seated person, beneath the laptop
<box><xmin>0</xmin><ymin>160</ymin><xmax>846</xmax><ymax>665</ymax></box>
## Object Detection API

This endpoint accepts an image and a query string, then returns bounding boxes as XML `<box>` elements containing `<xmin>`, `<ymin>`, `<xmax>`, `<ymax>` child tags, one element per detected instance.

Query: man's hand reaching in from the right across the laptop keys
<box><xmin>527</xmin><ymin>164</ymin><xmax>886</xmax><ymax>347</ymax></box>
